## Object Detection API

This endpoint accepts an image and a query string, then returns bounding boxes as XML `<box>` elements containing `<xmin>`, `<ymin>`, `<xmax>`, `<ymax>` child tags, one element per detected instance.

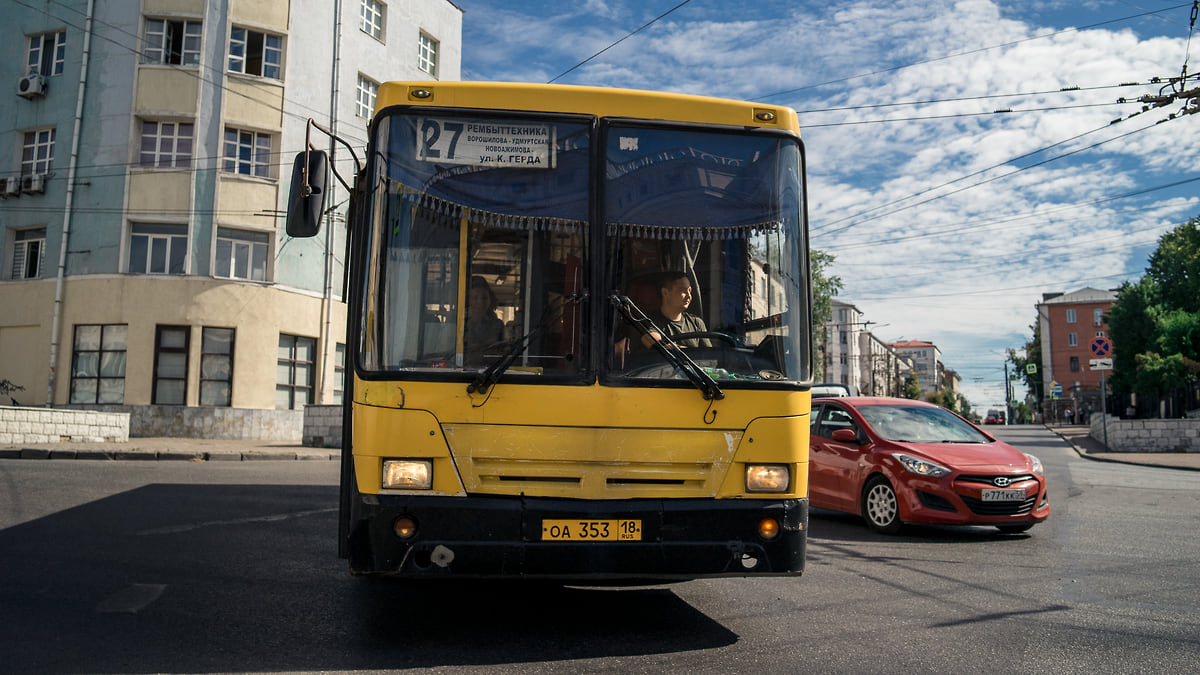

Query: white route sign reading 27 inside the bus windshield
<box><xmin>416</xmin><ymin>118</ymin><xmax>554</xmax><ymax>169</ymax></box>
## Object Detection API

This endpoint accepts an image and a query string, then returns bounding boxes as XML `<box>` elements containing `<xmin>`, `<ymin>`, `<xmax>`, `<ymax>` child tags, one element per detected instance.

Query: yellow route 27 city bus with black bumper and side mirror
<box><xmin>288</xmin><ymin>82</ymin><xmax>811</xmax><ymax>581</ymax></box>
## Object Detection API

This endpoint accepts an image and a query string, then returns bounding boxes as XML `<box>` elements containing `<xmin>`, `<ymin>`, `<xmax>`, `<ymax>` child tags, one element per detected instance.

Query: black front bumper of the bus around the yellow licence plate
<box><xmin>347</xmin><ymin>495</ymin><xmax>809</xmax><ymax>580</ymax></box>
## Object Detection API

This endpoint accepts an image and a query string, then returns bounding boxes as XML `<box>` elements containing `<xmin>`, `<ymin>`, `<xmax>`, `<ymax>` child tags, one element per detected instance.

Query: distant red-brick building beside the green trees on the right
<box><xmin>1038</xmin><ymin>288</ymin><xmax>1118</xmax><ymax>422</ymax></box>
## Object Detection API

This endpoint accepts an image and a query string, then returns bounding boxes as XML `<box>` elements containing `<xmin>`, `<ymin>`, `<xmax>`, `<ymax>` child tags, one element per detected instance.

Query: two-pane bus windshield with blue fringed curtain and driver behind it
<box><xmin>359</xmin><ymin>109</ymin><xmax>809</xmax><ymax>387</ymax></box>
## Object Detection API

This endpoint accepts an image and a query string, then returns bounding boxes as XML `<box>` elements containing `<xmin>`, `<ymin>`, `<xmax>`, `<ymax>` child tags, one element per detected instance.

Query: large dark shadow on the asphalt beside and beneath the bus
<box><xmin>0</xmin><ymin>485</ymin><xmax>738</xmax><ymax>673</ymax></box>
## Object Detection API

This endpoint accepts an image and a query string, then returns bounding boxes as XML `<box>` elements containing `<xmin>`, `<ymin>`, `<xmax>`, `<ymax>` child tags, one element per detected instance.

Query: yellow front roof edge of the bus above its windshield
<box><xmin>376</xmin><ymin>82</ymin><xmax>799</xmax><ymax>136</ymax></box>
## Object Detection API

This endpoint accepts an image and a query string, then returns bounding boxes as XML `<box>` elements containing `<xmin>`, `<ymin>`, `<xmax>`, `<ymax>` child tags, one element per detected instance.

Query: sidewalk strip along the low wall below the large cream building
<box><xmin>0</xmin><ymin>438</ymin><xmax>342</xmax><ymax>461</ymax></box>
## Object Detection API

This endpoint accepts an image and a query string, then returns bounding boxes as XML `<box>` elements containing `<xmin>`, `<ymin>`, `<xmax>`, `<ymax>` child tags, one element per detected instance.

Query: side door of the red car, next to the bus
<box><xmin>809</xmin><ymin>402</ymin><xmax>862</xmax><ymax>512</ymax></box>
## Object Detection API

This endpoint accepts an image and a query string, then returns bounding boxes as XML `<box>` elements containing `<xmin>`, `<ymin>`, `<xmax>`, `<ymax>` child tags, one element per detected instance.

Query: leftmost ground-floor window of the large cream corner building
<box><xmin>71</xmin><ymin>324</ymin><xmax>128</xmax><ymax>404</ymax></box>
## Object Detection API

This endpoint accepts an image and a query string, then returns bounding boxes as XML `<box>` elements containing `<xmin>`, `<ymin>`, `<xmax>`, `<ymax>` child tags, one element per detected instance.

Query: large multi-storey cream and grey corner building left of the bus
<box><xmin>0</xmin><ymin>0</ymin><xmax>462</xmax><ymax>436</ymax></box>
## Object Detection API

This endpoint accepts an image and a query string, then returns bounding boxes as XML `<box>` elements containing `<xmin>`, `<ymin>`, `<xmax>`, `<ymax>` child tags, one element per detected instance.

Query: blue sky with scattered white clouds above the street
<box><xmin>454</xmin><ymin>0</ymin><xmax>1200</xmax><ymax>411</ymax></box>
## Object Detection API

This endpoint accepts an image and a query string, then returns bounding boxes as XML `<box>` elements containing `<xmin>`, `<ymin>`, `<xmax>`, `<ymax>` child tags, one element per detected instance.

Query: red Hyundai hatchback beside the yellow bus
<box><xmin>809</xmin><ymin>398</ymin><xmax>1050</xmax><ymax>533</ymax></box>
